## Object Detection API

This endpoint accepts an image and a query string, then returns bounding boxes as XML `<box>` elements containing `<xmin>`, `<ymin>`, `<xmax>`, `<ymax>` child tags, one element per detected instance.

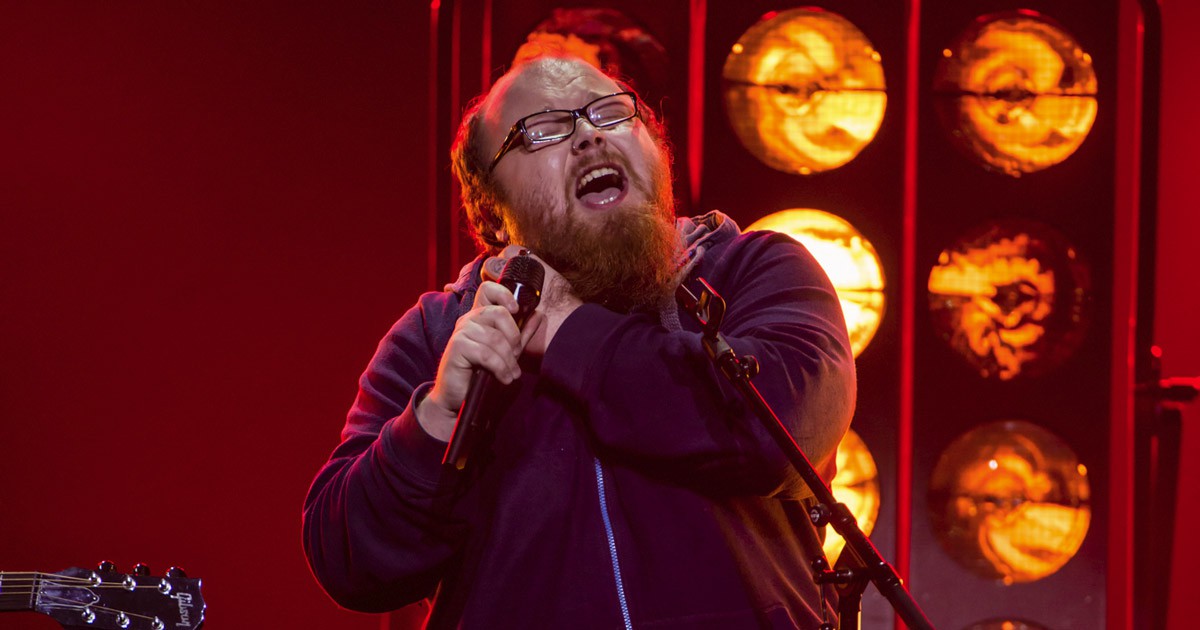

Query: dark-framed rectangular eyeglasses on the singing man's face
<box><xmin>488</xmin><ymin>92</ymin><xmax>637</xmax><ymax>172</ymax></box>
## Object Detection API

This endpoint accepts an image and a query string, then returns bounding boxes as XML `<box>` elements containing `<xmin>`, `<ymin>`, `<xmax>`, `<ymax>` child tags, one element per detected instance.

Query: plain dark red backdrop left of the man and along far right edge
<box><xmin>0</xmin><ymin>0</ymin><xmax>1200</xmax><ymax>629</ymax></box>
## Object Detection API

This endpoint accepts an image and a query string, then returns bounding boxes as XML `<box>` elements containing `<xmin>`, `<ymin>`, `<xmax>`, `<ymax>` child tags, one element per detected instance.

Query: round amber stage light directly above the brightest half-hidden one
<box><xmin>722</xmin><ymin>7</ymin><xmax>887</xmax><ymax>174</ymax></box>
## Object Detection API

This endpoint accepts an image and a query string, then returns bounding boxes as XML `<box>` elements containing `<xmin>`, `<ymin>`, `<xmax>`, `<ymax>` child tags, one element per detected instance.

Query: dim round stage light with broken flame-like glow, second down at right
<box><xmin>929</xmin><ymin>220</ymin><xmax>1092</xmax><ymax>380</ymax></box>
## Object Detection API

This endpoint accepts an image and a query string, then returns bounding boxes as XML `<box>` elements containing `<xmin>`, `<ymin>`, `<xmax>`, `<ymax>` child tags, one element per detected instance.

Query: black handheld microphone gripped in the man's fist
<box><xmin>442</xmin><ymin>250</ymin><xmax>546</xmax><ymax>470</ymax></box>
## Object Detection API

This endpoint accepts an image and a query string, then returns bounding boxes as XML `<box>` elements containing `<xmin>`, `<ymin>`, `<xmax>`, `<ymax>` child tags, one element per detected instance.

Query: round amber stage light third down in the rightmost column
<box><xmin>929</xmin><ymin>420</ymin><xmax>1092</xmax><ymax>584</ymax></box>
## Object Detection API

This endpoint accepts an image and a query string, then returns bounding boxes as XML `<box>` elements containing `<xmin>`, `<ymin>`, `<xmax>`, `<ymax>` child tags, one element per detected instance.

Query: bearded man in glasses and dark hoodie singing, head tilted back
<box><xmin>304</xmin><ymin>55</ymin><xmax>854</xmax><ymax>630</ymax></box>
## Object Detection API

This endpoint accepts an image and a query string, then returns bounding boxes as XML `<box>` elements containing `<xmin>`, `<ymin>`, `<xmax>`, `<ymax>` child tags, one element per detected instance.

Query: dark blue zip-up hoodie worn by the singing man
<box><xmin>304</xmin><ymin>215</ymin><xmax>856</xmax><ymax>630</ymax></box>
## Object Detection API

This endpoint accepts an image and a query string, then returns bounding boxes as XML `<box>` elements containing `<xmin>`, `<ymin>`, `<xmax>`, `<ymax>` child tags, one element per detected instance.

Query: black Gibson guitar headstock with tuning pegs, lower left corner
<box><xmin>31</xmin><ymin>562</ymin><xmax>205</xmax><ymax>630</ymax></box>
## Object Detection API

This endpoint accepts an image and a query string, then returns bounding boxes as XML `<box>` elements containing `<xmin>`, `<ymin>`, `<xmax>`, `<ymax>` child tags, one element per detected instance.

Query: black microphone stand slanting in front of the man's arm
<box><xmin>676</xmin><ymin>278</ymin><xmax>934</xmax><ymax>630</ymax></box>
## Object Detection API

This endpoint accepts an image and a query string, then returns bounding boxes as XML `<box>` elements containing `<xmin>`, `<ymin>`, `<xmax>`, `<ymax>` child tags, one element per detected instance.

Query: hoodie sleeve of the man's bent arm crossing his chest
<box><xmin>541</xmin><ymin>233</ymin><xmax>856</xmax><ymax>498</ymax></box>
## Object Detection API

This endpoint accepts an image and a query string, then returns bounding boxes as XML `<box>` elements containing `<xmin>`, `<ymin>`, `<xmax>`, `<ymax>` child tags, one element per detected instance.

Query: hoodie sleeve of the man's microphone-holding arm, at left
<box><xmin>302</xmin><ymin>293</ymin><xmax>468</xmax><ymax>612</ymax></box>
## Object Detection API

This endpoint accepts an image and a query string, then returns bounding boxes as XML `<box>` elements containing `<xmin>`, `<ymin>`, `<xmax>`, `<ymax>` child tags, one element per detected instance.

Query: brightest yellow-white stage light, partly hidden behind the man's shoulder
<box><xmin>748</xmin><ymin>208</ymin><xmax>884</xmax><ymax>356</ymax></box>
